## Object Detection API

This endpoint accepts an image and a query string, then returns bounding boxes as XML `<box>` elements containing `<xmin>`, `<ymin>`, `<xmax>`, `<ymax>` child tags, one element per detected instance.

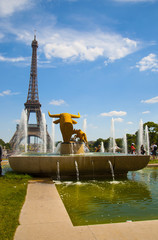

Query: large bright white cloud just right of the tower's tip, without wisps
<box><xmin>41</xmin><ymin>29</ymin><xmax>140</xmax><ymax>65</ymax></box>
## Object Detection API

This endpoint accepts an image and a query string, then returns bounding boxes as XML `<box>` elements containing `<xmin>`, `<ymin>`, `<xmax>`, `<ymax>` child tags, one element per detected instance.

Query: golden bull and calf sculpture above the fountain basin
<box><xmin>48</xmin><ymin>112</ymin><xmax>87</xmax><ymax>143</ymax></box>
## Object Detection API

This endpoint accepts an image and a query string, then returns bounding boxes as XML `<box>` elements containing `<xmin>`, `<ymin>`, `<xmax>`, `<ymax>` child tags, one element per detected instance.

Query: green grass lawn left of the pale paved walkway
<box><xmin>0</xmin><ymin>171</ymin><xmax>32</xmax><ymax>240</ymax></box>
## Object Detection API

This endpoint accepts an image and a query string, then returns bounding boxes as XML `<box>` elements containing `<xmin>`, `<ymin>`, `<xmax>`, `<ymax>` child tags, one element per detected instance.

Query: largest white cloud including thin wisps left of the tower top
<box><xmin>0</xmin><ymin>19</ymin><xmax>142</xmax><ymax>65</ymax></box>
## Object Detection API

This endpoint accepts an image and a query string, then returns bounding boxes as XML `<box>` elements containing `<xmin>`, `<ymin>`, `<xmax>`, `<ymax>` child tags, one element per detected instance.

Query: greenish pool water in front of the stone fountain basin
<box><xmin>56</xmin><ymin>168</ymin><xmax>158</xmax><ymax>226</ymax></box>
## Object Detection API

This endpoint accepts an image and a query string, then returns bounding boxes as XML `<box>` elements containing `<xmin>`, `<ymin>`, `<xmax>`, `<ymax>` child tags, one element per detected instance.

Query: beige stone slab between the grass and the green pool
<box><xmin>19</xmin><ymin>181</ymin><xmax>72</xmax><ymax>225</ymax></box>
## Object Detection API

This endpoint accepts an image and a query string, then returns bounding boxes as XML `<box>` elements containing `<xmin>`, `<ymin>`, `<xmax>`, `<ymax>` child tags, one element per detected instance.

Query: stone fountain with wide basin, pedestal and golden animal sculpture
<box><xmin>9</xmin><ymin>113</ymin><xmax>150</xmax><ymax>180</ymax></box>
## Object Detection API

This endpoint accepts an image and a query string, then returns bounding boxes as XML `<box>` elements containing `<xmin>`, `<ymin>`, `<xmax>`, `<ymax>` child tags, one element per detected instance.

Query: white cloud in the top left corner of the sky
<box><xmin>0</xmin><ymin>0</ymin><xmax>33</xmax><ymax>17</ymax></box>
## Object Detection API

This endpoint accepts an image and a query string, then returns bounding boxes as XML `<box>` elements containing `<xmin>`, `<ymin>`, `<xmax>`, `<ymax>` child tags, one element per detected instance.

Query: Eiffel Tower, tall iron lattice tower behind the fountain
<box><xmin>10</xmin><ymin>35</ymin><xmax>51</xmax><ymax>150</ymax></box>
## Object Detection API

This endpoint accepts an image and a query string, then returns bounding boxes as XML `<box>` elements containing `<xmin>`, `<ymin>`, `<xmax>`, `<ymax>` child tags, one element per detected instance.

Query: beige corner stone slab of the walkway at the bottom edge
<box><xmin>15</xmin><ymin>223</ymin><xmax>96</xmax><ymax>240</ymax></box>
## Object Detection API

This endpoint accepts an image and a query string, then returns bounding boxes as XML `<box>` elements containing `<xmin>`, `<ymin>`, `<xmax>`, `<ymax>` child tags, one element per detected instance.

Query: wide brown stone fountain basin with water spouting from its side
<box><xmin>9</xmin><ymin>154</ymin><xmax>150</xmax><ymax>179</ymax></box>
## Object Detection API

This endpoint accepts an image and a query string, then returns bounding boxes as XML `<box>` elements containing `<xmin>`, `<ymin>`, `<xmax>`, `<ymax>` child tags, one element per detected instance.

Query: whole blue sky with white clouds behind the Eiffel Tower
<box><xmin>0</xmin><ymin>0</ymin><xmax>158</xmax><ymax>142</ymax></box>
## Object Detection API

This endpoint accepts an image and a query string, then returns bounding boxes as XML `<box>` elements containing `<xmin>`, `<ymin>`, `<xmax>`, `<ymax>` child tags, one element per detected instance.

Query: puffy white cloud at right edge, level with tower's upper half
<box><xmin>136</xmin><ymin>53</ymin><xmax>158</xmax><ymax>72</ymax></box>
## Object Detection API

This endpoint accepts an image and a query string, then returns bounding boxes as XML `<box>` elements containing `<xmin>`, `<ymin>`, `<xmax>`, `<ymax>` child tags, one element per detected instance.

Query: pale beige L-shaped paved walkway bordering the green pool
<box><xmin>14</xmin><ymin>180</ymin><xmax>158</xmax><ymax>240</ymax></box>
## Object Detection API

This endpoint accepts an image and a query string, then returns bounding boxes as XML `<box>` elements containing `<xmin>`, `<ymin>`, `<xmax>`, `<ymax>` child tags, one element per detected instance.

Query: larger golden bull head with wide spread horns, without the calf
<box><xmin>48</xmin><ymin>112</ymin><xmax>80</xmax><ymax>142</ymax></box>
